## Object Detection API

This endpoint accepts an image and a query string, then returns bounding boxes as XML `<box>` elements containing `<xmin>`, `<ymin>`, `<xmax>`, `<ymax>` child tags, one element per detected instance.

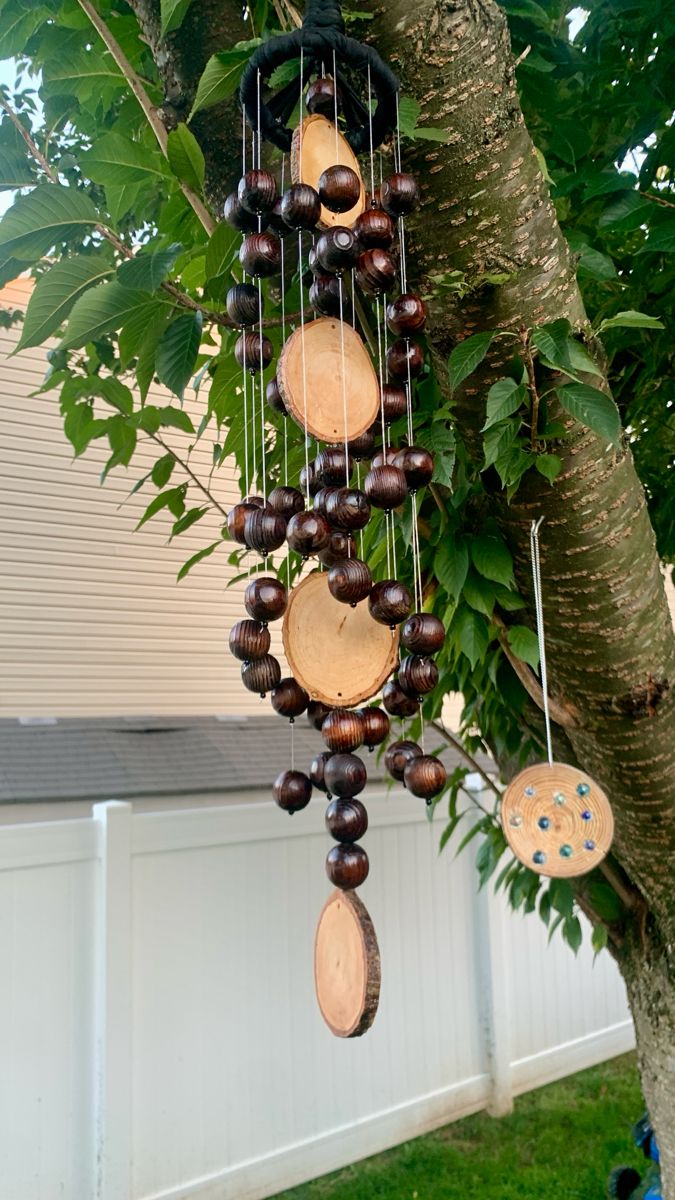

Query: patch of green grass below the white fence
<box><xmin>271</xmin><ymin>1054</ymin><xmax>647</xmax><ymax>1200</ymax></box>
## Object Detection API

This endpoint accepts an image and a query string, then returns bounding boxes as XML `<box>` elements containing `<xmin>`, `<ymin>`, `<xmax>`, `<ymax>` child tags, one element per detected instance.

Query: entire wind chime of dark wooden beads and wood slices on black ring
<box><xmin>225</xmin><ymin>0</ymin><xmax>446</xmax><ymax>1037</ymax></box>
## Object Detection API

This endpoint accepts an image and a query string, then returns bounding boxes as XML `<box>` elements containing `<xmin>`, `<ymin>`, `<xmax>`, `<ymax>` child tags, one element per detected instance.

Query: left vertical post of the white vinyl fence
<box><xmin>92</xmin><ymin>800</ymin><xmax>132</xmax><ymax>1200</ymax></box>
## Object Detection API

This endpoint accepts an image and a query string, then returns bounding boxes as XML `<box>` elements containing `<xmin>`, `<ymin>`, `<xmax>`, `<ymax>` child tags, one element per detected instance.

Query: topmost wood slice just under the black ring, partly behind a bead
<box><xmin>291</xmin><ymin>113</ymin><xmax>365</xmax><ymax>229</ymax></box>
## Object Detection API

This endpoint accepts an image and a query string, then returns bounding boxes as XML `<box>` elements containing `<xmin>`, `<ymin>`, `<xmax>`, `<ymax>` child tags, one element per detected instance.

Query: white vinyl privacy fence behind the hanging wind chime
<box><xmin>0</xmin><ymin>793</ymin><xmax>633</xmax><ymax>1200</ymax></box>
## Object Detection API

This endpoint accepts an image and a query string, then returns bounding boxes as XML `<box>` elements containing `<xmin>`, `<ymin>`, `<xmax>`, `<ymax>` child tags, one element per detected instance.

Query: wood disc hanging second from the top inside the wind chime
<box><xmin>276</xmin><ymin>317</ymin><xmax>380</xmax><ymax>442</ymax></box>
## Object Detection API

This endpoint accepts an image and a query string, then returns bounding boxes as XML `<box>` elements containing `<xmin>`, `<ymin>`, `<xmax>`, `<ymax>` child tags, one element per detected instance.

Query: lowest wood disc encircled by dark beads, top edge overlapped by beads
<box><xmin>283</xmin><ymin>571</ymin><xmax>399</xmax><ymax>708</ymax></box>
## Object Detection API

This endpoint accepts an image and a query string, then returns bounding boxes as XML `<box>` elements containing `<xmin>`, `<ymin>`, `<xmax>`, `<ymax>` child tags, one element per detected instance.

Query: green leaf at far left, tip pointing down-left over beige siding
<box><xmin>14</xmin><ymin>254</ymin><xmax>113</xmax><ymax>354</ymax></box>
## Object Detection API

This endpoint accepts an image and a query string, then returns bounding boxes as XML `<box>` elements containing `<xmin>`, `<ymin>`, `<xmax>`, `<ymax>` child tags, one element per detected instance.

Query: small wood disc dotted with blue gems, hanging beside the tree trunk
<box><xmin>501</xmin><ymin>762</ymin><xmax>614</xmax><ymax>878</ymax></box>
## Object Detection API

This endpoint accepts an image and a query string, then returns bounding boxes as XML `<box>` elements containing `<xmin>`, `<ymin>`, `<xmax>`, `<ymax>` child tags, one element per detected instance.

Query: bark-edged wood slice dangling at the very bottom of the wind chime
<box><xmin>313</xmin><ymin>892</ymin><xmax>380</xmax><ymax>1038</ymax></box>
